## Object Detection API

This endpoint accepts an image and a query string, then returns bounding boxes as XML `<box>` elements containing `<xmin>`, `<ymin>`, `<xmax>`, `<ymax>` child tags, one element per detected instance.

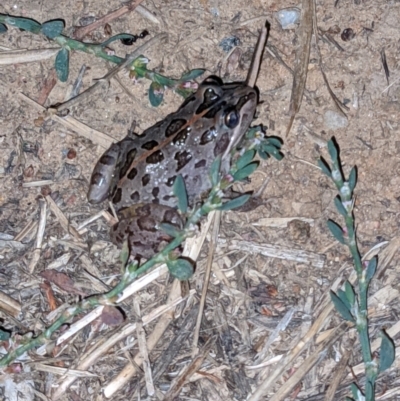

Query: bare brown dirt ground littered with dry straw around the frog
<box><xmin>0</xmin><ymin>0</ymin><xmax>400</xmax><ymax>400</ymax></box>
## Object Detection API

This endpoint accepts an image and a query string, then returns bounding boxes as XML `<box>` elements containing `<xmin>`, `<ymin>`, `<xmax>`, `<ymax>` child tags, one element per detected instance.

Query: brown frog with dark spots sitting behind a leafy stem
<box><xmin>88</xmin><ymin>77</ymin><xmax>257</xmax><ymax>258</ymax></box>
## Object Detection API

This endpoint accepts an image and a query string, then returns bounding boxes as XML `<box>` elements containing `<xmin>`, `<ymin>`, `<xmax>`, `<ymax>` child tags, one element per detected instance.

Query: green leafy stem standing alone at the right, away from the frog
<box><xmin>318</xmin><ymin>139</ymin><xmax>395</xmax><ymax>401</ymax></box>
